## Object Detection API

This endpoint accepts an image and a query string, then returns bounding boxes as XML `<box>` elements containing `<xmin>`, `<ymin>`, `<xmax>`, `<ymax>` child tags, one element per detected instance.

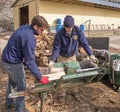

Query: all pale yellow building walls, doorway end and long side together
<box><xmin>14</xmin><ymin>0</ymin><xmax>120</xmax><ymax>29</ymax></box>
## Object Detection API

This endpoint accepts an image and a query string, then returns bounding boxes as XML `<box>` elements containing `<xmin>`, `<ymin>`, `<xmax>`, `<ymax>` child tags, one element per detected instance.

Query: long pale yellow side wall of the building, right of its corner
<box><xmin>39</xmin><ymin>1</ymin><xmax>120</xmax><ymax>29</ymax></box>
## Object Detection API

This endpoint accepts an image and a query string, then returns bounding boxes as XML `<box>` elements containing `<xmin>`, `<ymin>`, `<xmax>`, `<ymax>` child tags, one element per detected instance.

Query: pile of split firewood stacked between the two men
<box><xmin>35</xmin><ymin>33</ymin><xmax>54</xmax><ymax>67</ymax></box>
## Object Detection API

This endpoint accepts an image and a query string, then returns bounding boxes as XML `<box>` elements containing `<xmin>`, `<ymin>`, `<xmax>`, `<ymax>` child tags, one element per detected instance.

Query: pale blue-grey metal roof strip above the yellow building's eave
<box><xmin>79</xmin><ymin>0</ymin><xmax>120</xmax><ymax>8</ymax></box>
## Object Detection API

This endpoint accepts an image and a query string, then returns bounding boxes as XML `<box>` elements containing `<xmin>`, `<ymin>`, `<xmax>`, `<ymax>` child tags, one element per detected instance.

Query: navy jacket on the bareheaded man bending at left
<box><xmin>2</xmin><ymin>25</ymin><xmax>41</xmax><ymax>80</ymax></box>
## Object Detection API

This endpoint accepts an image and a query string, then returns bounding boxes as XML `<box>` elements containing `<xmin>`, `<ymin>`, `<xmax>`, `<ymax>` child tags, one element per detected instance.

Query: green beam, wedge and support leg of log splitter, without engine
<box><xmin>9</xmin><ymin>61</ymin><xmax>108</xmax><ymax>112</ymax></box>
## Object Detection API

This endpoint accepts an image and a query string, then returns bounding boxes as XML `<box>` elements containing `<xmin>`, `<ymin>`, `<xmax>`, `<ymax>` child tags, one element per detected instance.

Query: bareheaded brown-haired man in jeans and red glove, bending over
<box><xmin>2</xmin><ymin>15</ymin><xmax>49</xmax><ymax>112</ymax></box>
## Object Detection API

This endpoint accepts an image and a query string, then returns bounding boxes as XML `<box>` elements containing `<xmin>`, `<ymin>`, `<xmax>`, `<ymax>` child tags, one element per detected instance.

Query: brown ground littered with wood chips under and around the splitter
<box><xmin>0</xmin><ymin>33</ymin><xmax>120</xmax><ymax>112</ymax></box>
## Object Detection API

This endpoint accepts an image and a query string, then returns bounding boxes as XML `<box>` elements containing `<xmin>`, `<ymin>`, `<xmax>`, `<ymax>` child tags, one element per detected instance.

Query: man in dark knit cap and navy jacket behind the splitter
<box><xmin>49</xmin><ymin>15</ymin><xmax>97</xmax><ymax>104</ymax></box>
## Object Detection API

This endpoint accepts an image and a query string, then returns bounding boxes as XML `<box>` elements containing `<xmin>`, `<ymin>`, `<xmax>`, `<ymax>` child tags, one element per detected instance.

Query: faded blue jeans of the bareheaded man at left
<box><xmin>2</xmin><ymin>62</ymin><xmax>26</xmax><ymax>112</ymax></box>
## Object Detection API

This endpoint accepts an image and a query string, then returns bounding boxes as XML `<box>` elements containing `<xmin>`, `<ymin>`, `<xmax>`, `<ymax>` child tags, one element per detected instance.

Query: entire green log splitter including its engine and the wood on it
<box><xmin>9</xmin><ymin>50</ymin><xmax>120</xmax><ymax>112</ymax></box>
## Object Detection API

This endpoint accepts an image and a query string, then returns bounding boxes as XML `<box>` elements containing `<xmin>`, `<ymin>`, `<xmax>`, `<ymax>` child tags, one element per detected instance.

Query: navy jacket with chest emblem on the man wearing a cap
<box><xmin>50</xmin><ymin>26</ymin><xmax>92</xmax><ymax>61</ymax></box>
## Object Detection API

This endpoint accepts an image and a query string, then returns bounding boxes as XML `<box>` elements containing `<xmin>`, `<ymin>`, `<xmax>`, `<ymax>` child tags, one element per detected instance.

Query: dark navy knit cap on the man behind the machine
<box><xmin>63</xmin><ymin>15</ymin><xmax>74</xmax><ymax>28</ymax></box>
